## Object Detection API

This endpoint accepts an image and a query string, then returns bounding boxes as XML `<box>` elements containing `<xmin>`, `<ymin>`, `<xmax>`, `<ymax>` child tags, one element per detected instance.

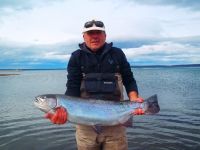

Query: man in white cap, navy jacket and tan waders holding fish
<box><xmin>47</xmin><ymin>20</ymin><xmax>143</xmax><ymax>150</ymax></box>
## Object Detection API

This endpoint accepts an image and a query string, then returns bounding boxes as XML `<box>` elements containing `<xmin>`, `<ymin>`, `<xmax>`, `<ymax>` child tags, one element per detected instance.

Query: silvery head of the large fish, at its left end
<box><xmin>34</xmin><ymin>94</ymin><xmax>58</xmax><ymax>113</ymax></box>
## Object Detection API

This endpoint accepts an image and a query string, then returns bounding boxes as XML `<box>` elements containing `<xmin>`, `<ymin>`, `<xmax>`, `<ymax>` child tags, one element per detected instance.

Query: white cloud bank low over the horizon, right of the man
<box><xmin>123</xmin><ymin>41</ymin><xmax>200</xmax><ymax>65</ymax></box>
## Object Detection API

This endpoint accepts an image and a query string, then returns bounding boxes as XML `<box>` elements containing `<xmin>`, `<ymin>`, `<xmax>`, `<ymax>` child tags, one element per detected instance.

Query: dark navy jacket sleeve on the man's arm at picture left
<box><xmin>65</xmin><ymin>51</ymin><xmax>82</xmax><ymax>97</ymax></box>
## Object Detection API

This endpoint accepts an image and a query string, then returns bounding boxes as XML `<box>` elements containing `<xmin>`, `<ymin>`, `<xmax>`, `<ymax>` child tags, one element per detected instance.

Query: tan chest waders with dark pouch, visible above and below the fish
<box><xmin>76</xmin><ymin>73</ymin><xmax>128</xmax><ymax>150</ymax></box>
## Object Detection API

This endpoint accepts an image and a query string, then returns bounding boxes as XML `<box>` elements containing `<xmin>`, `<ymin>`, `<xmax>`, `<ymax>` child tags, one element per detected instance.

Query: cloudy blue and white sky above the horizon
<box><xmin>0</xmin><ymin>0</ymin><xmax>200</xmax><ymax>69</ymax></box>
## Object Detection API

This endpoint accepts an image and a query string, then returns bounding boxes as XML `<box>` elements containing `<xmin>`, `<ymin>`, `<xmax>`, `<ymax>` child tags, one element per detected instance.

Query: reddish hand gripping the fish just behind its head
<box><xmin>45</xmin><ymin>107</ymin><xmax>67</xmax><ymax>124</ymax></box>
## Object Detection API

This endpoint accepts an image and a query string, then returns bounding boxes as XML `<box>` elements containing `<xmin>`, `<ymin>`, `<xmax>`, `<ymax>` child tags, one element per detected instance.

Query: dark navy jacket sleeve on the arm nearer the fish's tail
<box><xmin>118</xmin><ymin>49</ymin><xmax>138</xmax><ymax>94</ymax></box>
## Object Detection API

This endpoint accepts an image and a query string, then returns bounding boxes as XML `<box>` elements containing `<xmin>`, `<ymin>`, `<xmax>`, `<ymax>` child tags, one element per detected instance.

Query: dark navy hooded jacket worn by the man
<box><xmin>65</xmin><ymin>43</ymin><xmax>138</xmax><ymax>96</ymax></box>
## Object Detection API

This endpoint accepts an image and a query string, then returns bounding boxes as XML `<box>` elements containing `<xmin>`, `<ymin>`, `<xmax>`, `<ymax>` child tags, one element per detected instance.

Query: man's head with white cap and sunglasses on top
<box><xmin>83</xmin><ymin>20</ymin><xmax>106</xmax><ymax>52</ymax></box>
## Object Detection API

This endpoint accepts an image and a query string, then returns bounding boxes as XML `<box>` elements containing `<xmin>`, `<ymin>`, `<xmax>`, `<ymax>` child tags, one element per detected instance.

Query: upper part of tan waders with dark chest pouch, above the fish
<box><xmin>80</xmin><ymin>73</ymin><xmax>124</xmax><ymax>101</ymax></box>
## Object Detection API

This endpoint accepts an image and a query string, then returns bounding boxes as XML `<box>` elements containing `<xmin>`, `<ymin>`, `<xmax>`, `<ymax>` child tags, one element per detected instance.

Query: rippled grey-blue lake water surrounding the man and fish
<box><xmin>0</xmin><ymin>67</ymin><xmax>200</xmax><ymax>150</ymax></box>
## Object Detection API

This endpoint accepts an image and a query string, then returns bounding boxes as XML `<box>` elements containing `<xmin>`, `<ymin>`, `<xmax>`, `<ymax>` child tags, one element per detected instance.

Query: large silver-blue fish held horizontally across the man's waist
<box><xmin>34</xmin><ymin>94</ymin><xmax>160</xmax><ymax>126</ymax></box>
